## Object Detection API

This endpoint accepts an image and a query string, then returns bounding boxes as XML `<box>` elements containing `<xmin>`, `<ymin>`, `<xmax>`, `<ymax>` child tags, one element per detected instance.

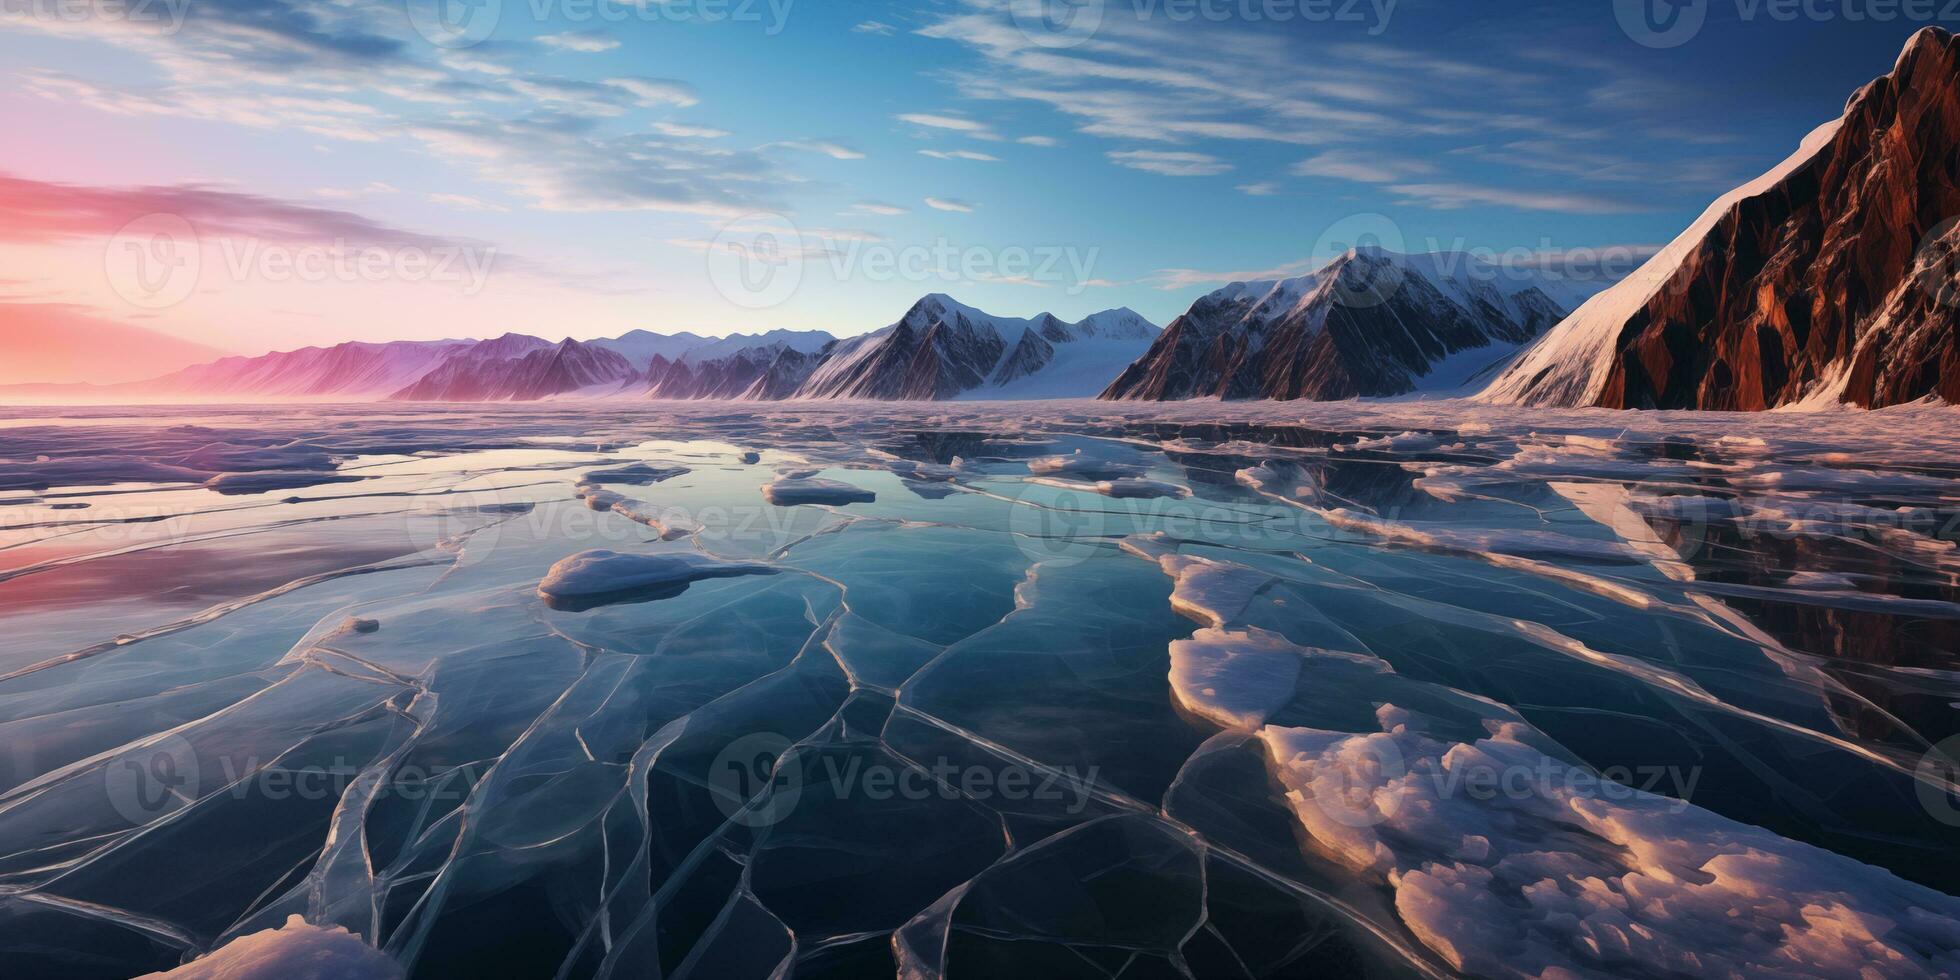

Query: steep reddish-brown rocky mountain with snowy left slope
<box><xmin>1478</xmin><ymin>27</ymin><xmax>1960</xmax><ymax>410</ymax></box>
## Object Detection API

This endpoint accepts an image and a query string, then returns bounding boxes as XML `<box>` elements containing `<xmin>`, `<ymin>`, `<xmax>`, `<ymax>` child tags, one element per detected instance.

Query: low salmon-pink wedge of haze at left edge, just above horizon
<box><xmin>0</xmin><ymin>302</ymin><xmax>223</xmax><ymax>384</ymax></box>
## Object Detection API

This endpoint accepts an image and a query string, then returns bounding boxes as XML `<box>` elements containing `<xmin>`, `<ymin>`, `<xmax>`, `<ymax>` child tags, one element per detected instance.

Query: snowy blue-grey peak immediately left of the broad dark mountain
<box><xmin>796</xmin><ymin>294</ymin><xmax>1156</xmax><ymax>400</ymax></box>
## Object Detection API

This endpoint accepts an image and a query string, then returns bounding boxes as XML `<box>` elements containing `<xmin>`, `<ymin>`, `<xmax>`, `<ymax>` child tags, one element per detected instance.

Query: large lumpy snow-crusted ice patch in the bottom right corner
<box><xmin>1260</xmin><ymin>706</ymin><xmax>1960</xmax><ymax>978</ymax></box>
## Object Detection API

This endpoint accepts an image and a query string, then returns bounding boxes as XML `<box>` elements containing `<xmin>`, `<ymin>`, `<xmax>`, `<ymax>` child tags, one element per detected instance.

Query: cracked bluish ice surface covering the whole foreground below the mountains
<box><xmin>0</xmin><ymin>402</ymin><xmax>1960</xmax><ymax>980</ymax></box>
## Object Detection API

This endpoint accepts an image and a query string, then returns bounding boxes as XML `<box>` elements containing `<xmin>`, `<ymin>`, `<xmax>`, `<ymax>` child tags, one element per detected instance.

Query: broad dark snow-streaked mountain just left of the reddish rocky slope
<box><xmin>1102</xmin><ymin>247</ymin><xmax>1584</xmax><ymax>400</ymax></box>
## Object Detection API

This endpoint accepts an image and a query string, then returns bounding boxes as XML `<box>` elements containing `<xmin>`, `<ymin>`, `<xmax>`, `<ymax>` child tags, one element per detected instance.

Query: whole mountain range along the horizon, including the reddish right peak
<box><xmin>0</xmin><ymin>27</ymin><xmax>1960</xmax><ymax>410</ymax></box>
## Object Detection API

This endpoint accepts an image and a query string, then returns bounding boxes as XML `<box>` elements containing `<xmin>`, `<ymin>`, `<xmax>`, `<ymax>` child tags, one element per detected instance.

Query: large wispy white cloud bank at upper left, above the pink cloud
<box><xmin>7</xmin><ymin>0</ymin><xmax>811</xmax><ymax>218</ymax></box>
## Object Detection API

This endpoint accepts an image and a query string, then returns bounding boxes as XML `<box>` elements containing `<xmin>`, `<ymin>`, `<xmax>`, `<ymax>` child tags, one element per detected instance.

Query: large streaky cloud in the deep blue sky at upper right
<box><xmin>917</xmin><ymin>0</ymin><xmax>1732</xmax><ymax>214</ymax></box>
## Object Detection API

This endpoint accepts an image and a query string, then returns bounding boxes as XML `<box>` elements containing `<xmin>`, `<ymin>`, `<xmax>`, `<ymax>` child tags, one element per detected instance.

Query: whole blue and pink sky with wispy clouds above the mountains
<box><xmin>0</xmin><ymin>0</ymin><xmax>1944</xmax><ymax>353</ymax></box>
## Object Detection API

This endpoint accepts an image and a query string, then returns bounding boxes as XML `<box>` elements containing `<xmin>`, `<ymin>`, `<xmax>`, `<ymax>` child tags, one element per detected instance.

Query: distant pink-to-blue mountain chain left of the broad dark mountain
<box><xmin>0</xmin><ymin>294</ymin><xmax>1158</xmax><ymax>402</ymax></box>
